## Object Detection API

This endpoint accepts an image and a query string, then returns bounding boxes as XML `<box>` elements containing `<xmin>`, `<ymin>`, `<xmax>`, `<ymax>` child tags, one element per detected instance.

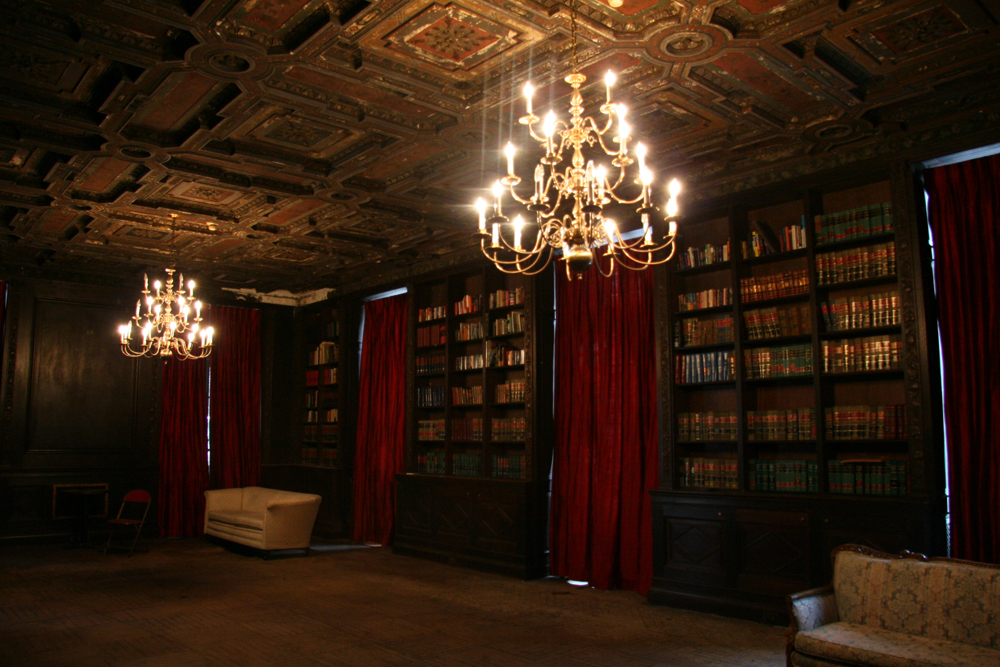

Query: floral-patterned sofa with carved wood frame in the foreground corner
<box><xmin>787</xmin><ymin>545</ymin><xmax>1000</xmax><ymax>667</ymax></box>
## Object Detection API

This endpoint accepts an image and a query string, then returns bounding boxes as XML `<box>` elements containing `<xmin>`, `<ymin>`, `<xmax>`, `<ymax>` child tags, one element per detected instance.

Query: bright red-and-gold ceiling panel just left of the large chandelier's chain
<box><xmin>385</xmin><ymin>3</ymin><xmax>518</xmax><ymax>70</ymax></box>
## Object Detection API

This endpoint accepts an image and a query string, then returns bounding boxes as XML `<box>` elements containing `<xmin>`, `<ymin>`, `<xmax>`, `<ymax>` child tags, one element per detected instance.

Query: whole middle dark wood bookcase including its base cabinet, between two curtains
<box><xmin>394</xmin><ymin>266</ymin><xmax>552</xmax><ymax>578</ymax></box>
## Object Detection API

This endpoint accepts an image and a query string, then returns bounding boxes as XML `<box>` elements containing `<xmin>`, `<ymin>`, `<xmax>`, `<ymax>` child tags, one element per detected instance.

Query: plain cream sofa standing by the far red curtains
<box><xmin>205</xmin><ymin>486</ymin><xmax>321</xmax><ymax>551</ymax></box>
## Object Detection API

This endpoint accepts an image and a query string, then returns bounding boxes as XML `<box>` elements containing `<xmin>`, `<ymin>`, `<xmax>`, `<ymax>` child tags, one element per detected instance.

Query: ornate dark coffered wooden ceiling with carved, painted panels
<box><xmin>0</xmin><ymin>0</ymin><xmax>1000</xmax><ymax>292</ymax></box>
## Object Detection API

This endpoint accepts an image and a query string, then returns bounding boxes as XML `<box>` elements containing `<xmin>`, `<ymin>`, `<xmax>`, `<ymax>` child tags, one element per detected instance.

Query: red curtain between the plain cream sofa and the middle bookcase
<box><xmin>351</xmin><ymin>294</ymin><xmax>406</xmax><ymax>546</ymax></box>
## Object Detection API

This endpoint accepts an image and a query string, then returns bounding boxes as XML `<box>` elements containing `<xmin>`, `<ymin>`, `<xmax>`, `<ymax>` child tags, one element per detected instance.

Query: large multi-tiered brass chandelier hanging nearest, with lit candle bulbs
<box><xmin>476</xmin><ymin>0</ymin><xmax>680</xmax><ymax>280</ymax></box>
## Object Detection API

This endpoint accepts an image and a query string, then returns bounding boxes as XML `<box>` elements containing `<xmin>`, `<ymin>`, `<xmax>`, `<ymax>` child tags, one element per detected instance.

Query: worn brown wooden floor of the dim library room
<box><xmin>0</xmin><ymin>539</ymin><xmax>784</xmax><ymax>667</ymax></box>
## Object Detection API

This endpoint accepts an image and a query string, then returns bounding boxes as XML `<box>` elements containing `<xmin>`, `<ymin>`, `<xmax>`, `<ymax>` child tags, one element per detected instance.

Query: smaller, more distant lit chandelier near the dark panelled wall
<box><xmin>118</xmin><ymin>268</ymin><xmax>215</xmax><ymax>359</ymax></box>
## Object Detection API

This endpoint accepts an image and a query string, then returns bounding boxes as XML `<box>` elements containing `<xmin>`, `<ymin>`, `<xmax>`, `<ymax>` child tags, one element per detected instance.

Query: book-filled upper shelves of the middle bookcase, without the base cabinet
<box><xmin>408</xmin><ymin>269</ymin><xmax>533</xmax><ymax>480</ymax></box>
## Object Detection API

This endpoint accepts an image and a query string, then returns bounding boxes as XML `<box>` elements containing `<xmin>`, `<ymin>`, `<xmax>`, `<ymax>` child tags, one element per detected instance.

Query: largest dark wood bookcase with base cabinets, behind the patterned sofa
<box><xmin>650</xmin><ymin>169</ymin><xmax>944</xmax><ymax>622</ymax></box>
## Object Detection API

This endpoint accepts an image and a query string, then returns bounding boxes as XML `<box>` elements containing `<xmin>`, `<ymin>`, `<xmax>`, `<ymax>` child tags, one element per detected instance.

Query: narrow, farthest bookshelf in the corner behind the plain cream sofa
<box><xmin>300</xmin><ymin>306</ymin><xmax>343</xmax><ymax>468</ymax></box>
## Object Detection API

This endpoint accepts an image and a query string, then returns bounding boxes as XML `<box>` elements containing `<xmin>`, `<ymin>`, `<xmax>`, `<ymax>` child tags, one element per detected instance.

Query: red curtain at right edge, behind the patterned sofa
<box><xmin>925</xmin><ymin>155</ymin><xmax>1000</xmax><ymax>563</ymax></box>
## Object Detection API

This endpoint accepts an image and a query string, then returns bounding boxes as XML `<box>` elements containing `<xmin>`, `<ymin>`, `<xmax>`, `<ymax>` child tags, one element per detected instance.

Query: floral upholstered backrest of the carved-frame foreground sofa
<box><xmin>833</xmin><ymin>551</ymin><xmax>1000</xmax><ymax>649</ymax></box>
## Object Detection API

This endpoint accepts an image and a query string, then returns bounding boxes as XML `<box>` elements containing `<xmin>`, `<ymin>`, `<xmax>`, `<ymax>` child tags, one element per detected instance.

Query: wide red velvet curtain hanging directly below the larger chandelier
<box><xmin>550</xmin><ymin>268</ymin><xmax>659</xmax><ymax>595</ymax></box>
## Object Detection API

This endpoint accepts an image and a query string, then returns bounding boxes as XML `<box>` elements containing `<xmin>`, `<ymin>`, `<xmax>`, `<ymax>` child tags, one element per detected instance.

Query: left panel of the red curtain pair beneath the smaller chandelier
<box><xmin>157</xmin><ymin>359</ymin><xmax>208</xmax><ymax>537</ymax></box>
